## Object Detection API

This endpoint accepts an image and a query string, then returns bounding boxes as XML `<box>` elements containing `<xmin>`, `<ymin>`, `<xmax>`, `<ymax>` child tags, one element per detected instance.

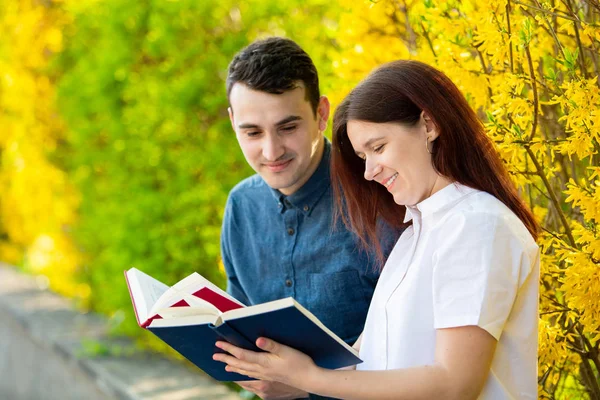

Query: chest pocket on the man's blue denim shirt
<box><xmin>308</xmin><ymin>270</ymin><xmax>372</xmax><ymax>344</ymax></box>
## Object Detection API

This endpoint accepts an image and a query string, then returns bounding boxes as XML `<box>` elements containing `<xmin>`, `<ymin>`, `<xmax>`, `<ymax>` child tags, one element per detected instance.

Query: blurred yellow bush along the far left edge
<box><xmin>0</xmin><ymin>0</ymin><xmax>88</xmax><ymax>297</ymax></box>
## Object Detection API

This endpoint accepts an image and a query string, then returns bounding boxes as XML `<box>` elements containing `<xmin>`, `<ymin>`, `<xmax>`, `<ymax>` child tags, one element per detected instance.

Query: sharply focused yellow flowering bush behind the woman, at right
<box><xmin>334</xmin><ymin>0</ymin><xmax>600</xmax><ymax>399</ymax></box>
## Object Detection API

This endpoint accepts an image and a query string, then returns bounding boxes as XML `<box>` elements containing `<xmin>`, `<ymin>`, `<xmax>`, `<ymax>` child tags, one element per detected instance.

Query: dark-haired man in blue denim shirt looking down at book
<box><xmin>221</xmin><ymin>37</ymin><xmax>396</xmax><ymax>399</ymax></box>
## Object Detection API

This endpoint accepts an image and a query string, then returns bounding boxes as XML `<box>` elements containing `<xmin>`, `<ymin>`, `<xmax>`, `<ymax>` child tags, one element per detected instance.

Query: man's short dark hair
<box><xmin>227</xmin><ymin>37</ymin><xmax>321</xmax><ymax>116</ymax></box>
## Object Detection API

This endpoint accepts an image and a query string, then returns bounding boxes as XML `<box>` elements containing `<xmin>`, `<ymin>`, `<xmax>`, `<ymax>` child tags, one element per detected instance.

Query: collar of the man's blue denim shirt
<box><xmin>271</xmin><ymin>138</ymin><xmax>331</xmax><ymax>215</ymax></box>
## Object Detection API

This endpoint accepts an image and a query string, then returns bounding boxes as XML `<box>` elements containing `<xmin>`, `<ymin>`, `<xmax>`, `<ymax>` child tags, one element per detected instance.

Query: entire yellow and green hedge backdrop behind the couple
<box><xmin>0</xmin><ymin>0</ymin><xmax>600</xmax><ymax>399</ymax></box>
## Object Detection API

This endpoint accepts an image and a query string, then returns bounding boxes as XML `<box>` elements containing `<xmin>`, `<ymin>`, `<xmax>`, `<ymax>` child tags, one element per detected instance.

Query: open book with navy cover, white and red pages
<box><xmin>125</xmin><ymin>268</ymin><xmax>362</xmax><ymax>381</ymax></box>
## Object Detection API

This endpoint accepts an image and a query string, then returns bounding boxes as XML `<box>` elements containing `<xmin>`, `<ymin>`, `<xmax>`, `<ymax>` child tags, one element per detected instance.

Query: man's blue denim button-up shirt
<box><xmin>221</xmin><ymin>140</ymin><xmax>395</xmax><ymax>344</ymax></box>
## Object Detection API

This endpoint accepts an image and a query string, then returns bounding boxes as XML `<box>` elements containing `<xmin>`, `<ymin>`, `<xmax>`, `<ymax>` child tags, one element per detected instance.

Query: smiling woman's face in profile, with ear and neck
<box><xmin>347</xmin><ymin>115</ymin><xmax>447</xmax><ymax>206</ymax></box>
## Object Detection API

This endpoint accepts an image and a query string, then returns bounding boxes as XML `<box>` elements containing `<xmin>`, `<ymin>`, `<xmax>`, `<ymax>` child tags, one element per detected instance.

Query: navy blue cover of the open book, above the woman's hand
<box><xmin>148</xmin><ymin>298</ymin><xmax>362</xmax><ymax>381</ymax></box>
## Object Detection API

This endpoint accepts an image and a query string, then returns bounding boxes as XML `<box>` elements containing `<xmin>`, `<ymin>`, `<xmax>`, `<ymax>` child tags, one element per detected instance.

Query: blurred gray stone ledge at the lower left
<box><xmin>0</xmin><ymin>262</ymin><xmax>240</xmax><ymax>400</ymax></box>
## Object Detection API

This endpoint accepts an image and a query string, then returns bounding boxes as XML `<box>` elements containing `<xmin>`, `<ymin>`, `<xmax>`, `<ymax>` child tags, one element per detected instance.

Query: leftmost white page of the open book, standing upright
<box><xmin>126</xmin><ymin>268</ymin><xmax>169</xmax><ymax>324</ymax></box>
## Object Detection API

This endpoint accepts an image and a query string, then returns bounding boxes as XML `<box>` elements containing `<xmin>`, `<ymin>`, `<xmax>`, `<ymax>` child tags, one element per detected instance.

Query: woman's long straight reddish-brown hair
<box><xmin>331</xmin><ymin>60</ymin><xmax>539</xmax><ymax>261</ymax></box>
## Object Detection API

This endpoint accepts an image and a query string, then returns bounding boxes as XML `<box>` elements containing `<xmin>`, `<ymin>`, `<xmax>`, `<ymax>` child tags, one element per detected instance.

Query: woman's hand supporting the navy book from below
<box><xmin>213</xmin><ymin>338</ymin><xmax>319</xmax><ymax>392</ymax></box>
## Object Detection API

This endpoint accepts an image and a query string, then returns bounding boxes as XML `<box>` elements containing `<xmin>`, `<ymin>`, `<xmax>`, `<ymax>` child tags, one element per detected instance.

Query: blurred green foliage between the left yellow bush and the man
<box><xmin>53</xmin><ymin>0</ymin><xmax>344</xmax><ymax>340</ymax></box>
